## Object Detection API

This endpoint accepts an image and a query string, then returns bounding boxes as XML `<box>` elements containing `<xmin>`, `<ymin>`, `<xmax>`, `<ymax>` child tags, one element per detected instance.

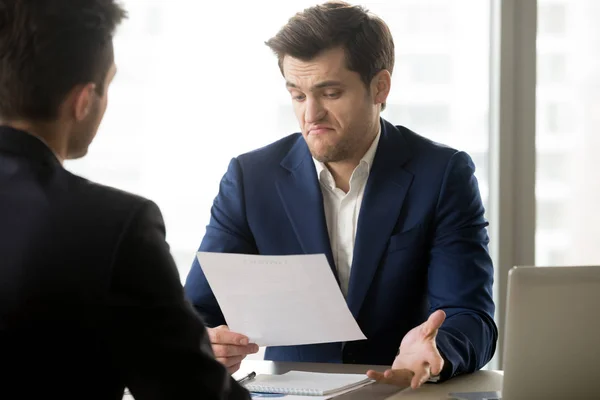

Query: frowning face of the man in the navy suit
<box><xmin>283</xmin><ymin>48</ymin><xmax>379</xmax><ymax>163</ymax></box>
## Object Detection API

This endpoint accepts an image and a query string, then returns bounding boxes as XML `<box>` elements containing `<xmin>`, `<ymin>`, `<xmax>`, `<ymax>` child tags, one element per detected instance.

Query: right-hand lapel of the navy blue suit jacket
<box><xmin>348</xmin><ymin>120</ymin><xmax>413</xmax><ymax>318</ymax></box>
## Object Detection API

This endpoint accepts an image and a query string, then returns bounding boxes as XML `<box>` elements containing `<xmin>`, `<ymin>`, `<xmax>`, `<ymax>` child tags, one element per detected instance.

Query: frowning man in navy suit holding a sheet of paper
<box><xmin>185</xmin><ymin>2</ymin><xmax>497</xmax><ymax>387</ymax></box>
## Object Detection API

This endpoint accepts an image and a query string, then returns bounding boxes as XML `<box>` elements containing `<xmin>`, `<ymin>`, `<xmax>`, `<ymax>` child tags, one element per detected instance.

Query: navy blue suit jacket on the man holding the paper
<box><xmin>185</xmin><ymin>119</ymin><xmax>498</xmax><ymax>378</ymax></box>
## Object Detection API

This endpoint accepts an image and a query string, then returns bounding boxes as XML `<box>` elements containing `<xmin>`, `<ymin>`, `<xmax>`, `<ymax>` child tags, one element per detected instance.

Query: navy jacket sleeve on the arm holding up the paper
<box><xmin>185</xmin><ymin>158</ymin><xmax>258</xmax><ymax>333</ymax></box>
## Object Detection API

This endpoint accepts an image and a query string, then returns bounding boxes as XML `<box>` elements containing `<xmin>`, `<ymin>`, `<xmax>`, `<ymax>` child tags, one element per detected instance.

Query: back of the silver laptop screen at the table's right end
<box><xmin>502</xmin><ymin>267</ymin><xmax>600</xmax><ymax>400</ymax></box>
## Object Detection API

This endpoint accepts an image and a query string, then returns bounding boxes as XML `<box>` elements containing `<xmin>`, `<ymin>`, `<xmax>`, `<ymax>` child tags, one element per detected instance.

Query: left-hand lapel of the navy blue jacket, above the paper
<box><xmin>276</xmin><ymin>137</ymin><xmax>339</xmax><ymax>283</ymax></box>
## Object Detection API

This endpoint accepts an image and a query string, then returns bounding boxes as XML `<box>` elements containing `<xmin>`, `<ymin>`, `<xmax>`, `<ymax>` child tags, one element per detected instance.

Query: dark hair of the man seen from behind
<box><xmin>0</xmin><ymin>0</ymin><xmax>126</xmax><ymax>120</ymax></box>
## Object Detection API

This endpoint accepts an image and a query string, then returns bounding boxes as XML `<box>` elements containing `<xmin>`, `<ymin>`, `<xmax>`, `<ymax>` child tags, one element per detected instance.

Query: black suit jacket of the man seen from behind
<box><xmin>0</xmin><ymin>127</ymin><xmax>249</xmax><ymax>399</ymax></box>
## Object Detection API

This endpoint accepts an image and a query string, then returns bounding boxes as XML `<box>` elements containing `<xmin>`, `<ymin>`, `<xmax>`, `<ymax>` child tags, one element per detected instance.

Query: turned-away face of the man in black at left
<box><xmin>67</xmin><ymin>63</ymin><xmax>117</xmax><ymax>159</ymax></box>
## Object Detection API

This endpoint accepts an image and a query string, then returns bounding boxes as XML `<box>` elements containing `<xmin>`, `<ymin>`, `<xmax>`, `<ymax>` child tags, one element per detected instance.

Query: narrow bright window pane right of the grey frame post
<box><xmin>536</xmin><ymin>0</ymin><xmax>600</xmax><ymax>266</ymax></box>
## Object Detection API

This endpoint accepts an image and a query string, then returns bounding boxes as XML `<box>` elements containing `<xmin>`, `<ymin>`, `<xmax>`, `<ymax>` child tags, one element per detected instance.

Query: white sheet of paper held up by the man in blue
<box><xmin>197</xmin><ymin>252</ymin><xmax>366</xmax><ymax>346</ymax></box>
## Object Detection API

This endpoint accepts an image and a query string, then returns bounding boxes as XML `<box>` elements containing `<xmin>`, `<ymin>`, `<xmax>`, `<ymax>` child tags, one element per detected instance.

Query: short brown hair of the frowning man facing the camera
<box><xmin>266</xmin><ymin>1</ymin><xmax>394</xmax><ymax>90</ymax></box>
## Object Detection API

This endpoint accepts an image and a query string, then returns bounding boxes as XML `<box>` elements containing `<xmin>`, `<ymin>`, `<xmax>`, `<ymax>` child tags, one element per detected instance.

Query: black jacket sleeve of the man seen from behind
<box><xmin>108</xmin><ymin>201</ymin><xmax>249</xmax><ymax>399</ymax></box>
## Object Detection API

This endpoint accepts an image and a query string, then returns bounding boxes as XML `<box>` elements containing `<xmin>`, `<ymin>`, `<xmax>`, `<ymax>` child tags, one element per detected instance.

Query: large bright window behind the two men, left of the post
<box><xmin>67</xmin><ymin>0</ymin><xmax>490</xmax><ymax>279</ymax></box>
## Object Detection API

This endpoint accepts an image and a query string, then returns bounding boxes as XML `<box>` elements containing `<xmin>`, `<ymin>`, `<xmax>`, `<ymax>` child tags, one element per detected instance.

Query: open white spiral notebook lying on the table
<box><xmin>245</xmin><ymin>371</ymin><xmax>372</xmax><ymax>396</ymax></box>
